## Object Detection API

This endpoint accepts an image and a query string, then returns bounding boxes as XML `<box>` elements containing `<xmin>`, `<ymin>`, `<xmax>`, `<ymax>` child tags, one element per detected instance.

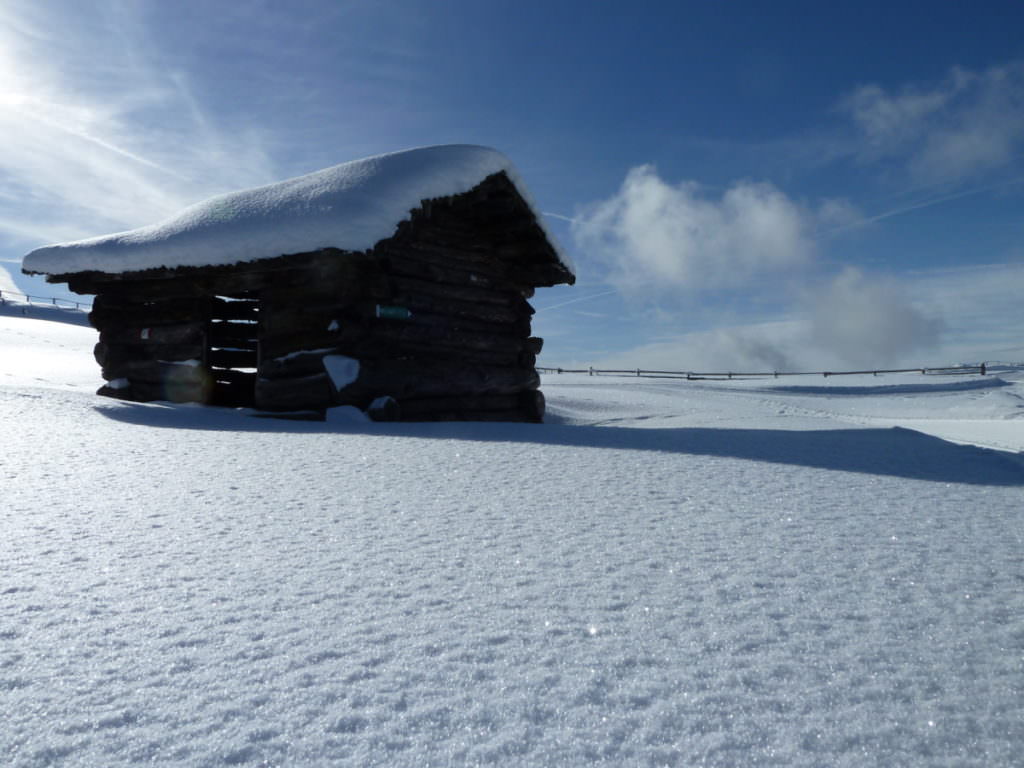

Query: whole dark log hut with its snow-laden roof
<box><xmin>23</xmin><ymin>145</ymin><xmax>574</xmax><ymax>421</ymax></box>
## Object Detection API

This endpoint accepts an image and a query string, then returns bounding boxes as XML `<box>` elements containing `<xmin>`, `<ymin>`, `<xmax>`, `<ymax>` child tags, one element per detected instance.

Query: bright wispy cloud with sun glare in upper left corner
<box><xmin>0</xmin><ymin>0</ymin><xmax>272</xmax><ymax>248</ymax></box>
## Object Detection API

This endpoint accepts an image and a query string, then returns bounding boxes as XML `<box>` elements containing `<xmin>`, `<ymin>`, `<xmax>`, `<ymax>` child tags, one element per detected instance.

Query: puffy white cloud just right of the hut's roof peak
<box><xmin>572</xmin><ymin>165</ymin><xmax>841</xmax><ymax>296</ymax></box>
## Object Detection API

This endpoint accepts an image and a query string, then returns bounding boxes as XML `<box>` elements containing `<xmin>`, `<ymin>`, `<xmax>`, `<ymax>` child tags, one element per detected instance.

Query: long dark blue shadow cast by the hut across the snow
<box><xmin>95</xmin><ymin>402</ymin><xmax>1024</xmax><ymax>486</ymax></box>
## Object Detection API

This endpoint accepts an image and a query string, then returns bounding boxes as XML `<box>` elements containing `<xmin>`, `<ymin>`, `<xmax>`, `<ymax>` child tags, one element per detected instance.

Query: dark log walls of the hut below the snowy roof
<box><xmin>58</xmin><ymin>174</ymin><xmax>573</xmax><ymax>421</ymax></box>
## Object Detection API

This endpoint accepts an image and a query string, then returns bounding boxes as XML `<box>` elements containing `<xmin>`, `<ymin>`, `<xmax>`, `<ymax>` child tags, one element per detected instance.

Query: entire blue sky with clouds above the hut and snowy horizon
<box><xmin>0</xmin><ymin>0</ymin><xmax>1024</xmax><ymax>370</ymax></box>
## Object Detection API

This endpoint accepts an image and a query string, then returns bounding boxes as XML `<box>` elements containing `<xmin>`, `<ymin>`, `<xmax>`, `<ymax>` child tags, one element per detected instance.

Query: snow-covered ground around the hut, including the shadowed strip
<box><xmin>0</xmin><ymin>305</ymin><xmax>1024</xmax><ymax>768</ymax></box>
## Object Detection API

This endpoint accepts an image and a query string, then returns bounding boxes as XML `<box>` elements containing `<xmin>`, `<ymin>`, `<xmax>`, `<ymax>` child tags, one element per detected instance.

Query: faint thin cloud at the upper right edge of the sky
<box><xmin>840</xmin><ymin>61</ymin><xmax>1024</xmax><ymax>184</ymax></box>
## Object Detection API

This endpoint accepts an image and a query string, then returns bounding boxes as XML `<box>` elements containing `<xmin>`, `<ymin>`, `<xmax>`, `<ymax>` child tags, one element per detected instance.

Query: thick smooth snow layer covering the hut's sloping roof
<box><xmin>23</xmin><ymin>144</ymin><xmax>572</xmax><ymax>274</ymax></box>
